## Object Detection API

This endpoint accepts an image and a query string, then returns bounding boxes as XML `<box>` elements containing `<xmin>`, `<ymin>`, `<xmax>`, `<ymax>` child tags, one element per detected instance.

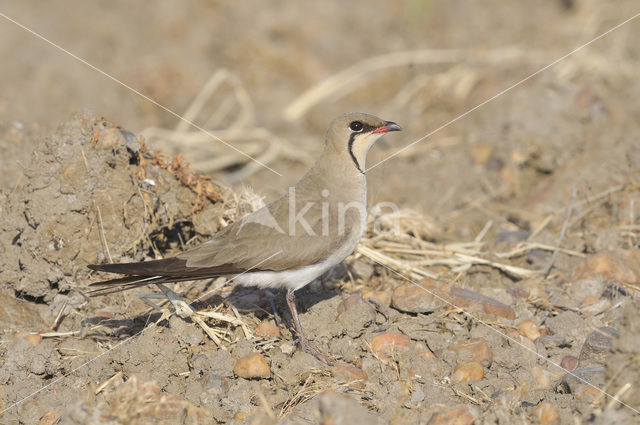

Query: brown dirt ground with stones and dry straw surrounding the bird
<box><xmin>0</xmin><ymin>0</ymin><xmax>640</xmax><ymax>425</ymax></box>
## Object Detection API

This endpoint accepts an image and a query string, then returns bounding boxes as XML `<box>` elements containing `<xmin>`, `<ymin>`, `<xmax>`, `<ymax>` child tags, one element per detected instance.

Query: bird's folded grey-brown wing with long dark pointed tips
<box><xmin>89</xmin><ymin>174</ymin><xmax>360</xmax><ymax>293</ymax></box>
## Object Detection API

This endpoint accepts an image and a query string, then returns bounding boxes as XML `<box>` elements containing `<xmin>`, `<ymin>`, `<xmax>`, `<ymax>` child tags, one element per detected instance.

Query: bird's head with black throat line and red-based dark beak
<box><xmin>327</xmin><ymin>112</ymin><xmax>402</xmax><ymax>172</ymax></box>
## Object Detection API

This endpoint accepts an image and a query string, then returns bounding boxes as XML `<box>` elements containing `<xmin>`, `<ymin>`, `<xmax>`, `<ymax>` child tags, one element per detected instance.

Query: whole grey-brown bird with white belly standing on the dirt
<box><xmin>88</xmin><ymin>112</ymin><xmax>402</xmax><ymax>360</ymax></box>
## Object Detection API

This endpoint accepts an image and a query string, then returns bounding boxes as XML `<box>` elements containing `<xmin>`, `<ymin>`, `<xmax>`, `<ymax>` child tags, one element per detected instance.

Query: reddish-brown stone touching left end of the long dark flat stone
<box><xmin>391</xmin><ymin>279</ymin><xmax>451</xmax><ymax>313</ymax></box>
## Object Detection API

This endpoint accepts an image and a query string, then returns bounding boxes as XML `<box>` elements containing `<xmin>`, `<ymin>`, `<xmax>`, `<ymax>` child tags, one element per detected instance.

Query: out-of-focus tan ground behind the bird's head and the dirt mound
<box><xmin>0</xmin><ymin>0</ymin><xmax>640</xmax><ymax>236</ymax></box>
